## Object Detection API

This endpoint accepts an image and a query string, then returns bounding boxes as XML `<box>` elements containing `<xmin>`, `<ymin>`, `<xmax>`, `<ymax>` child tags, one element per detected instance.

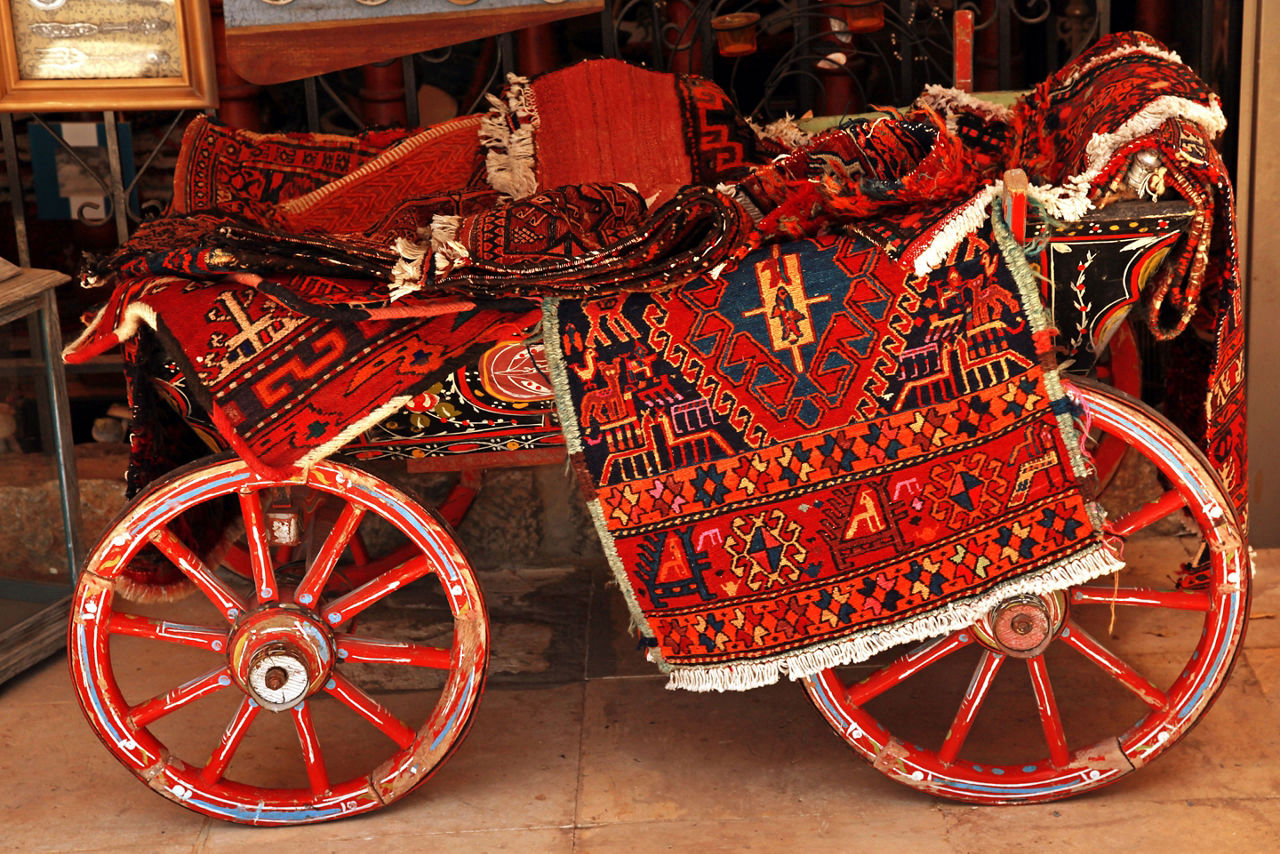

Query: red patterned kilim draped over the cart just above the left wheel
<box><xmin>68</xmin><ymin>277</ymin><xmax>539</xmax><ymax>471</ymax></box>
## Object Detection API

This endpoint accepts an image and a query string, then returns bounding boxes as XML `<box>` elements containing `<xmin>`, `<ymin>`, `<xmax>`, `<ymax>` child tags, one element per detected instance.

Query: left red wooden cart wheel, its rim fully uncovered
<box><xmin>68</xmin><ymin>458</ymin><xmax>489</xmax><ymax>825</ymax></box>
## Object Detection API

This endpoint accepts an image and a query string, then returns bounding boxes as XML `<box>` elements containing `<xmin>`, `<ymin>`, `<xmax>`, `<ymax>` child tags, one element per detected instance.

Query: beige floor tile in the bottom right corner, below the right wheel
<box><xmin>942</xmin><ymin>787</ymin><xmax>1280</xmax><ymax>854</ymax></box>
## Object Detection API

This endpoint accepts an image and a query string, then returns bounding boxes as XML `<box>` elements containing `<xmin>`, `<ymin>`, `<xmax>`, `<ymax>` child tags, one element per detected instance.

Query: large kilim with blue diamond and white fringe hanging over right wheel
<box><xmin>548</xmin><ymin>224</ymin><xmax>1115</xmax><ymax>690</ymax></box>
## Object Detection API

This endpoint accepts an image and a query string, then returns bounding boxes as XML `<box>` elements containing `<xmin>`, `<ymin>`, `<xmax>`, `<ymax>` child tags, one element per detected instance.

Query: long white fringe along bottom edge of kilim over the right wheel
<box><xmin>667</xmin><ymin>545</ymin><xmax>1124</xmax><ymax>693</ymax></box>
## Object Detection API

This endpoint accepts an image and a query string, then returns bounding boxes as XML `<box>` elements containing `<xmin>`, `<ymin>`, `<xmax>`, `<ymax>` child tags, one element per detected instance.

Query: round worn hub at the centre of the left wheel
<box><xmin>228</xmin><ymin>604</ymin><xmax>334</xmax><ymax>712</ymax></box>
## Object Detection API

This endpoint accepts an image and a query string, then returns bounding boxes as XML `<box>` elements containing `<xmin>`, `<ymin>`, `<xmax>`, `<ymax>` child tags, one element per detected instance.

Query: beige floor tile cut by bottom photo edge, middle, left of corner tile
<box><xmin>576</xmin><ymin>802</ymin><xmax>951</xmax><ymax>854</ymax></box>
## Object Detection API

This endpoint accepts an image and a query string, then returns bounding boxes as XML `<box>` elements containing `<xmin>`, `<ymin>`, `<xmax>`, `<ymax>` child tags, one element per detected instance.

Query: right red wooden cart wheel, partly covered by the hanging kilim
<box><xmin>805</xmin><ymin>380</ymin><xmax>1251</xmax><ymax>804</ymax></box>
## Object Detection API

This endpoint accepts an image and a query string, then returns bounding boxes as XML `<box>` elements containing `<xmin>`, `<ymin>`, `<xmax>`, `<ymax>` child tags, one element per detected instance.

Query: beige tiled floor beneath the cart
<box><xmin>0</xmin><ymin>551</ymin><xmax>1280</xmax><ymax>854</ymax></box>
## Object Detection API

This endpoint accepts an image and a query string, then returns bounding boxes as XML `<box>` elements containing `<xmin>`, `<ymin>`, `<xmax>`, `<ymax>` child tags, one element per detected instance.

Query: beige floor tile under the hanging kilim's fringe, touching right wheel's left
<box><xmin>579</xmin><ymin>679</ymin><xmax>928</xmax><ymax>825</ymax></box>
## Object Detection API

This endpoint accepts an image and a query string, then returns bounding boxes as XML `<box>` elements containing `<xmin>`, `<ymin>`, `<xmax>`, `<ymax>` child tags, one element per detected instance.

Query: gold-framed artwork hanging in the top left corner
<box><xmin>0</xmin><ymin>0</ymin><xmax>216</xmax><ymax>113</ymax></box>
